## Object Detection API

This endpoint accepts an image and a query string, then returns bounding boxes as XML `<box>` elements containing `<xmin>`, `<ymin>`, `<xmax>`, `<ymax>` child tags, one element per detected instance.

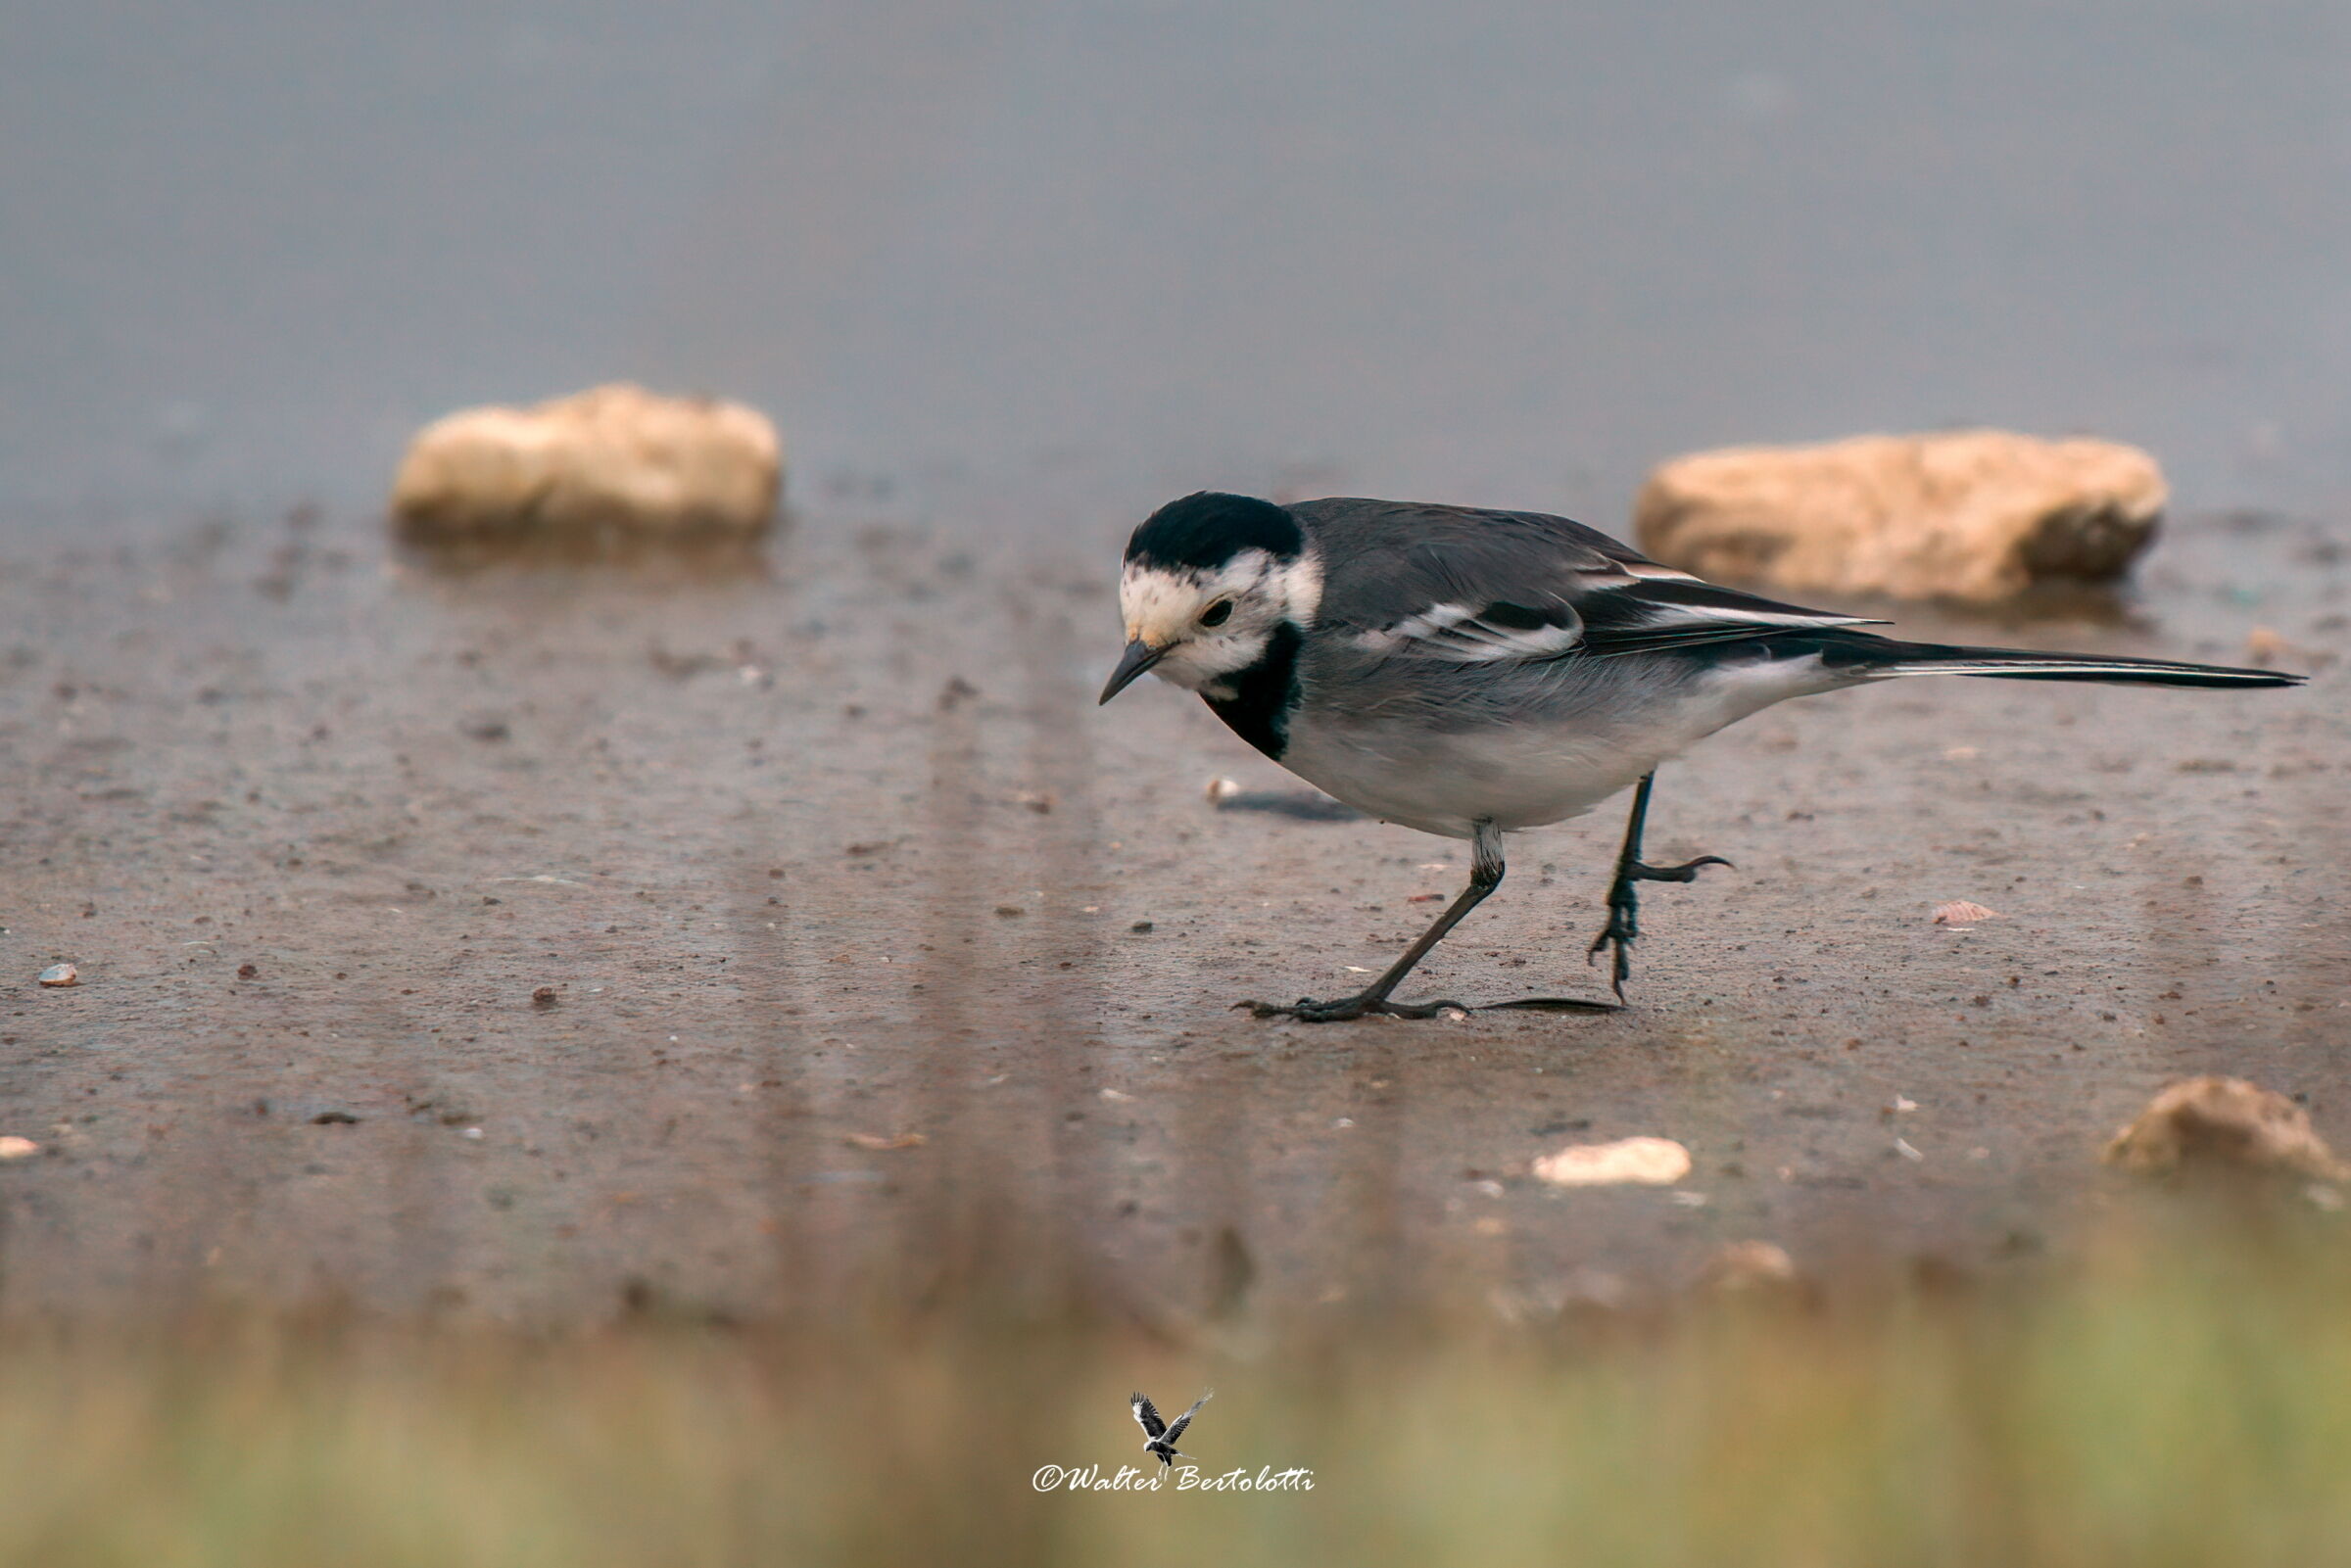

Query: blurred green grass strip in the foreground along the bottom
<box><xmin>0</xmin><ymin>1220</ymin><xmax>2351</xmax><ymax>1568</ymax></box>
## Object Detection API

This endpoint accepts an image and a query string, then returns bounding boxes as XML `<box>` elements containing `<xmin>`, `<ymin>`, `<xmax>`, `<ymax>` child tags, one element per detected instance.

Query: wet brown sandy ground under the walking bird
<box><xmin>0</xmin><ymin>505</ymin><xmax>2351</xmax><ymax>1321</ymax></box>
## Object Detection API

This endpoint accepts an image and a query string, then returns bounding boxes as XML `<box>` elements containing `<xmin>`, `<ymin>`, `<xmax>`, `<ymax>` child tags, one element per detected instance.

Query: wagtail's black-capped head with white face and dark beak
<box><xmin>1103</xmin><ymin>492</ymin><xmax>1321</xmax><ymax>703</ymax></box>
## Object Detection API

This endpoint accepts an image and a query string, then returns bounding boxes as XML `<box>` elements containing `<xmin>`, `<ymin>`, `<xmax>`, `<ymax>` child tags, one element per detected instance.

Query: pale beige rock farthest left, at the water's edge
<box><xmin>393</xmin><ymin>383</ymin><xmax>783</xmax><ymax>541</ymax></box>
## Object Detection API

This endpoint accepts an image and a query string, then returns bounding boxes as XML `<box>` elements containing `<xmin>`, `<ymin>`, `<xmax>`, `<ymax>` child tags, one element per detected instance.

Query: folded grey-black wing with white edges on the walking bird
<box><xmin>1291</xmin><ymin>500</ymin><xmax>1867</xmax><ymax>663</ymax></box>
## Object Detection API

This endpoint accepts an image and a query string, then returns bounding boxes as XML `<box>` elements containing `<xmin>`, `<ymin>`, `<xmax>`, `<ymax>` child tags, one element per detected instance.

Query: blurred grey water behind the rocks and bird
<box><xmin>0</xmin><ymin>0</ymin><xmax>2351</xmax><ymax>527</ymax></box>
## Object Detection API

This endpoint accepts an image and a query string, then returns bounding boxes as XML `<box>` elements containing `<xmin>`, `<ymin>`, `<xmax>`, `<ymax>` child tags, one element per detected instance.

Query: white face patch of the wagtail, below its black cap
<box><xmin>1119</xmin><ymin>550</ymin><xmax>1321</xmax><ymax>695</ymax></box>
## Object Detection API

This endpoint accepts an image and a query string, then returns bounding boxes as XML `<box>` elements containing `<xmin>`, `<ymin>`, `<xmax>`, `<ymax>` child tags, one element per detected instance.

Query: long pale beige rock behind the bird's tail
<box><xmin>1634</xmin><ymin>430</ymin><xmax>2168</xmax><ymax>601</ymax></box>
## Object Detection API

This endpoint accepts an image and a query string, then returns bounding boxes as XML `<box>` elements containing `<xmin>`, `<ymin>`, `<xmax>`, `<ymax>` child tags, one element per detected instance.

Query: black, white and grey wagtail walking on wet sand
<box><xmin>1100</xmin><ymin>492</ymin><xmax>2304</xmax><ymax>1022</ymax></box>
